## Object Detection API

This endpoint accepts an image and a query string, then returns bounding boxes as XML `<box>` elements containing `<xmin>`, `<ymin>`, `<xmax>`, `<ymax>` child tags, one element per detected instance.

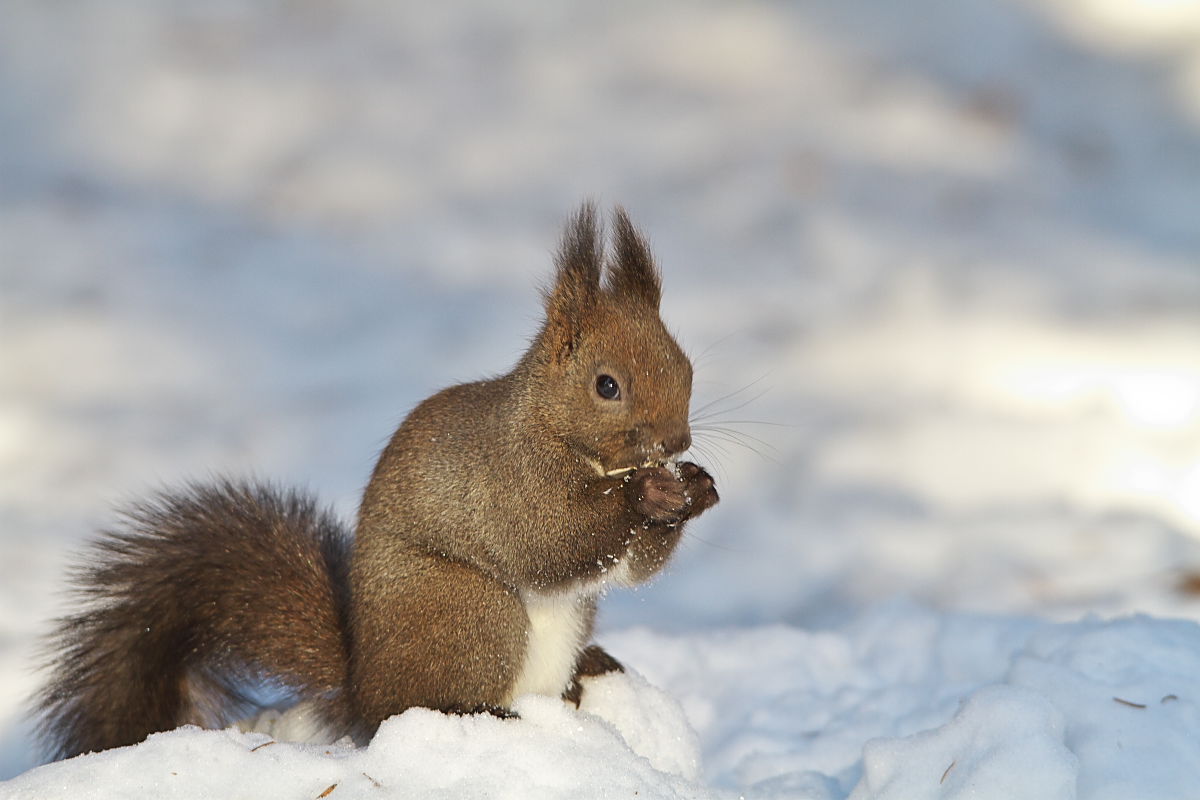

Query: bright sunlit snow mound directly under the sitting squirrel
<box><xmin>0</xmin><ymin>675</ymin><xmax>718</xmax><ymax>800</ymax></box>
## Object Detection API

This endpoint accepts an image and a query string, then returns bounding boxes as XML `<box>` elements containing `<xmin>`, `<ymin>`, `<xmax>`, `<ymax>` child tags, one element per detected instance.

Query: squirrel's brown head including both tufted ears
<box><xmin>529</xmin><ymin>204</ymin><xmax>691</xmax><ymax>475</ymax></box>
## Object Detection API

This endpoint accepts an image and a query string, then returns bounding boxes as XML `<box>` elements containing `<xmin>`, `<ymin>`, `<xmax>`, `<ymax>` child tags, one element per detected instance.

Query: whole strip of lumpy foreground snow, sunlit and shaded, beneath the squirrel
<box><xmin>9</xmin><ymin>602</ymin><xmax>1200</xmax><ymax>800</ymax></box>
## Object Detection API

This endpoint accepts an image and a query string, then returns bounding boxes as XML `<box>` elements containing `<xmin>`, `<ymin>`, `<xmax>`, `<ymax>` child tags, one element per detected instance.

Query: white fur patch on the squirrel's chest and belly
<box><xmin>508</xmin><ymin>563</ymin><xmax>628</xmax><ymax>705</ymax></box>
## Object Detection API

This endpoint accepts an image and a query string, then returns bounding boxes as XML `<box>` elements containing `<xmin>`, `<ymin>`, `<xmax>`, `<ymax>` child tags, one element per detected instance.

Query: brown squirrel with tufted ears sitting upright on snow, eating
<box><xmin>36</xmin><ymin>204</ymin><xmax>718</xmax><ymax>757</ymax></box>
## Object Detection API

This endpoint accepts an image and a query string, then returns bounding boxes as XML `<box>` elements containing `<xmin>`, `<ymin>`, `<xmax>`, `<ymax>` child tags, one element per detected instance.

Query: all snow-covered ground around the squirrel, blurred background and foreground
<box><xmin>0</xmin><ymin>0</ymin><xmax>1200</xmax><ymax>800</ymax></box>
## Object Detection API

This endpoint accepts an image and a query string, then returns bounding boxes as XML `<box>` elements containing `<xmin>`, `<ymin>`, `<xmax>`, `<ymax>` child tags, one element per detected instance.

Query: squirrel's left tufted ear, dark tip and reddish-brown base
<box><xmin>542</xmin><ymin>201</ymin><xmax>604</xmax><ymax>356</ymax></box>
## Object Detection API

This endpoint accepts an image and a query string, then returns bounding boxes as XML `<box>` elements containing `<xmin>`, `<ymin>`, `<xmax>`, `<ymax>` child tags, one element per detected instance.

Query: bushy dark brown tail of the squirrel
<box><xmin>37</xmin><ymin>482</ymin><xmax>350</xmax><ymax>757</ymax></box>
